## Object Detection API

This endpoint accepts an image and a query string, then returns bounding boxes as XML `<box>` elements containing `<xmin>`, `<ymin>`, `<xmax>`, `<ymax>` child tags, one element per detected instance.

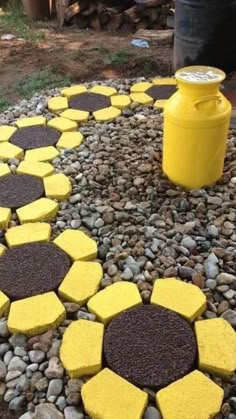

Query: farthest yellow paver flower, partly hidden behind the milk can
<box><xmin>130</xmin><ymin>78</ymin><xmax>177</xmax><ymax>108</ymax></box>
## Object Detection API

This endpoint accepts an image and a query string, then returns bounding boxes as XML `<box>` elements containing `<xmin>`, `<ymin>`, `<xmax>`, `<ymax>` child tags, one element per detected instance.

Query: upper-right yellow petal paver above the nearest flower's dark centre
<box><xmin>151</xmin><ymin>278</ymin><xmax>206</xmax><ymax>322</ymax></box>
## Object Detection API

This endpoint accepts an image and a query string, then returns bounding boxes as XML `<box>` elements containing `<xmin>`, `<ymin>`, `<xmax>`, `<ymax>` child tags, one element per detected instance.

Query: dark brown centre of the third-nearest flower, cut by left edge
<box><xmin>0</xmin><ymin>175</ymin><xmax>44</xmax><ymax>209</ymax></box>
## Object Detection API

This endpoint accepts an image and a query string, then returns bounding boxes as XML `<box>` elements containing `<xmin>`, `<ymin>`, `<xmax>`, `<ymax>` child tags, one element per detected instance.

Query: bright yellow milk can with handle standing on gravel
<box><xmin>163</xmin><ymin>66</ymin><xmax>231</xmax><ymax>189</ymax></box>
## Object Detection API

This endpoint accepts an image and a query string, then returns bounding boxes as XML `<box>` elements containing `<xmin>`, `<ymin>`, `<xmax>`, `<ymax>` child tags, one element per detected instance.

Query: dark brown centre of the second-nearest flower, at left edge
<box><xmin>0</xmin><ymin>243</ymin><xmax>70</xmax><ymax>302</ymax></box>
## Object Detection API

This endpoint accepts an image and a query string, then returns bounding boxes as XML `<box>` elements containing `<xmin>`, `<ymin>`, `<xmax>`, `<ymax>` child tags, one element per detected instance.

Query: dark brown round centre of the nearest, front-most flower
<box><xmin>104</xmin><ymin>305</ymin><xmax>197</xmax><ymax>390</ymax></box>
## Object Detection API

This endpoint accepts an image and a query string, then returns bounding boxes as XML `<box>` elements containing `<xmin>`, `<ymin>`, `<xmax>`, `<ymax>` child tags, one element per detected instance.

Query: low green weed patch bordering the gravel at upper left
<box><xmin>12</xmin><ymin>68</ymin><xmax>71</xmax><ymax>99</ymax></box>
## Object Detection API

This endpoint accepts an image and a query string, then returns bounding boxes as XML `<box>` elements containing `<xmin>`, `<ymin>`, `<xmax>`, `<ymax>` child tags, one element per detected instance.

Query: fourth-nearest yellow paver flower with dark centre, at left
<box><xmin>0</xmin><ymin>116</ymin><xmax>83</xmax><ymax>162</ymax></box>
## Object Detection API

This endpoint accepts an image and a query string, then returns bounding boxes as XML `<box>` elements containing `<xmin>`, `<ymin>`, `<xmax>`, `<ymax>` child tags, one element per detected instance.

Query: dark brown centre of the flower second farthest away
<box><xmin>70</xmin><ymin>92</ymin><xmax>111</xmax><ymax>112</ymax></box>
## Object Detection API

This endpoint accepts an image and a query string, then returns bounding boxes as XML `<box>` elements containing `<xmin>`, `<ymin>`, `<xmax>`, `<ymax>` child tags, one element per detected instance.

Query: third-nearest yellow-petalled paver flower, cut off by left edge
<box><xmin>0</xmin><ymin>161</ymin><xmax>72</xmax><ymax>230</ymax></box>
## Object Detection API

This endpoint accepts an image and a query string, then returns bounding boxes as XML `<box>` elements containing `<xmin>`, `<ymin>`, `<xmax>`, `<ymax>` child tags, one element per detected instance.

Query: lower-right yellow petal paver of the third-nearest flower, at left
<box><xmin>16</xmin><ymin>198</ymin><xmax>58</xmax><ymax>224</ymax></box>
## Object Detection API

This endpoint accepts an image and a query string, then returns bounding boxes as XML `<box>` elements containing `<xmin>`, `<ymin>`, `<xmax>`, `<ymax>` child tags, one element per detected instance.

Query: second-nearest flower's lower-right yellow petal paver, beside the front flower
<box><xmin>58</xmin><ymin>261</ymin><xmax>103</xmax><ymax>305</ymax></box>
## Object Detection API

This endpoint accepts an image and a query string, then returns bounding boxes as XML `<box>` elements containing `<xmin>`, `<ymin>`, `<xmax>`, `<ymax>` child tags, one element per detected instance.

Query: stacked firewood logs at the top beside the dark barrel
<box><xmin>56</xmin><ymin>0</ymin><xmax>174</xmax><ymax>31</ymax></box>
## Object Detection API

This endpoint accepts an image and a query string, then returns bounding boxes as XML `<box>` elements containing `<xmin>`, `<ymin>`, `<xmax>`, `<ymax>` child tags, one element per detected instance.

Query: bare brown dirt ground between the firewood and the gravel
<box><xmin>0</xmin><ymin>23</ymin><xmax>172</xmax><ymax>102</ymax></box>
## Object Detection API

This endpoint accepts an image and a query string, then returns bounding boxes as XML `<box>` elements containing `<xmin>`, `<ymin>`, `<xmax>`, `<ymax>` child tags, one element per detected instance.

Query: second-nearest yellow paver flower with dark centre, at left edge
<box><xmin>0</xmin><ymin>223</ymin><xmax>103</xmax><ymax>335</ymax></box>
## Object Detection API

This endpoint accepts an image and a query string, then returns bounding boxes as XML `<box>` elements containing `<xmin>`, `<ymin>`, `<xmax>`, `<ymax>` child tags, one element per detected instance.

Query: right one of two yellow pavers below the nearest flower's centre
<box><xmin>156</xmin><ymin>371</ymin><xmax>224</xmax><ymax>419</ymax></box>
